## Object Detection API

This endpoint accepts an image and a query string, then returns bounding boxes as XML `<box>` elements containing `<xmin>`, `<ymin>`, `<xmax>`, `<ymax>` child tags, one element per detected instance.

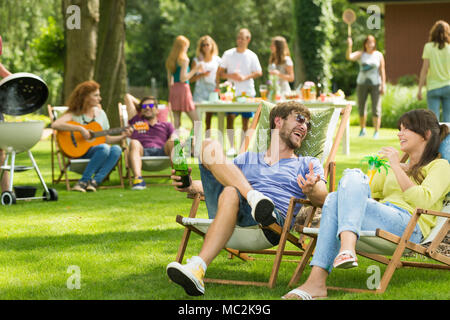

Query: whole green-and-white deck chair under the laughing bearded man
<box><xmin>176</xmin><ymin>102</ymin><xmax>352</xmax><ymax>288</ymax></box>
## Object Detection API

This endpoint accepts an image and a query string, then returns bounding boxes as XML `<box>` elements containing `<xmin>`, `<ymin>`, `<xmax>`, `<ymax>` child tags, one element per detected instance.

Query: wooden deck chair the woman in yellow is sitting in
<box><xmin>289</xmin><ymin>124</ymin><xmax>450</xmax><ymax>293</ymax></box>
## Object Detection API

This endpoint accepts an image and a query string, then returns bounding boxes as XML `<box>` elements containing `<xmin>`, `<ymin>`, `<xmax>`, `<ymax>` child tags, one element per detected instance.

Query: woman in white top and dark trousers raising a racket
<box><xmin>346</xmin><ymin>35</ymin><xmax>386</xmax><ymax>139</ymax></box>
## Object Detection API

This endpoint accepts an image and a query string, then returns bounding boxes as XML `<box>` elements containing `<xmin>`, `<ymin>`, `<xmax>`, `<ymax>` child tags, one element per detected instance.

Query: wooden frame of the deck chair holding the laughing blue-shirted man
<box><xmin>176</xmin><ymin>105</ymin><xmax>352</xmax><ymax>288</ymax></box>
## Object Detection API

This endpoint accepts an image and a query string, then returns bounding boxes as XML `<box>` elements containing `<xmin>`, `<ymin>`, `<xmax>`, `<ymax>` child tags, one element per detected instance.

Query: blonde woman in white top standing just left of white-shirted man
<box><xmin>191</xmin><ymin>35</ymin><xmax>221</xmax><ymax>132</ymax></box>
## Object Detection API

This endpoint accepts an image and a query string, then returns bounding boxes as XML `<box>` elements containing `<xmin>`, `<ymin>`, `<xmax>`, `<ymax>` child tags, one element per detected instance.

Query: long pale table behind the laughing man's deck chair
<box><xmin>195</xmin><ymin>99</ymin><xmax>355</xmax><ymax>155</ymax></box>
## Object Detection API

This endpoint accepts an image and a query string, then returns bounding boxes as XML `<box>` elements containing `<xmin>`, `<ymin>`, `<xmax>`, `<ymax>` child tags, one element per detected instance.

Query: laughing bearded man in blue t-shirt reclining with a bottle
<box><xmin>167</xmin><ymin>101</ymin><xmax>328</xmax><ymax>295</ymax></box>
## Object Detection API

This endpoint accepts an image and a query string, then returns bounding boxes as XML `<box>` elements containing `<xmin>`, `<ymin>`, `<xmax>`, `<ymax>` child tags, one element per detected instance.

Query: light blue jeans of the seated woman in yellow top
<box><xmin>311</xmin><ymin>169</ymin><xmax>422</xmax><ymax>272</ymax></box>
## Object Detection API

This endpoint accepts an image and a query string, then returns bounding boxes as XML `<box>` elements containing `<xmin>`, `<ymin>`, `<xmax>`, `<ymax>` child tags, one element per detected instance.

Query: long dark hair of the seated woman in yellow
<box><xmin>397</xmin><ymin>109</ymin><xmax>448</xmax><ymax>183</ymax></box>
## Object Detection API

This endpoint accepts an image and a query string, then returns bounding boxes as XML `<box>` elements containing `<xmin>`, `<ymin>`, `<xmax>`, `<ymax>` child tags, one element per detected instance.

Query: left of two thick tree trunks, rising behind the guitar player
<box><xmin>62</xmin><ymin>0</ymin><xmax>100</xmax><ymax>101</ymax></box>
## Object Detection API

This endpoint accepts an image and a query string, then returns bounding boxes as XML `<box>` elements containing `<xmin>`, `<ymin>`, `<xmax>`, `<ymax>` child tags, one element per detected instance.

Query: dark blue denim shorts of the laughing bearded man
<box><xmin>198</xmin><ymin>163</ymin><xmax>284</xmax><ymax>245</ymax></box>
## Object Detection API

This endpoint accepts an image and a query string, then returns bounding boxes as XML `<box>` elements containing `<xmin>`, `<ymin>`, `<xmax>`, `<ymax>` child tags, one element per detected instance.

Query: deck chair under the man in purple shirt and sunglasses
<box><xmin>118</xmin><ymin>102</ymin><xmax>171</xmax><ymax>187</ymax></box>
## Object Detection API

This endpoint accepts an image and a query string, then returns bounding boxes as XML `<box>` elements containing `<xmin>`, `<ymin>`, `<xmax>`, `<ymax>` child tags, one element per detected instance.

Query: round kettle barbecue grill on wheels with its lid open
<box><xmin>0</xmin><ymin>73</ymin><xmax>58</xmax><ymax>205</ymax></box>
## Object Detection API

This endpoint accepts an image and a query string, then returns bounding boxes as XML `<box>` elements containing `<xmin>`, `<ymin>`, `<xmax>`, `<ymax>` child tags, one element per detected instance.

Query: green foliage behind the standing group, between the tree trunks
<box><xmin>126</xmin><ymin>0</ymin><xmax>293</xmax><ymax>98</ymax></box>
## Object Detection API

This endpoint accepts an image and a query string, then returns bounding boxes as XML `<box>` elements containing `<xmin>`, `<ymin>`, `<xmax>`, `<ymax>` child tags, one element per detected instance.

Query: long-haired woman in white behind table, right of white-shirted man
<box><xmin>269</xmin><ymin>36</ymin><xmax>295</xmax><ymax>95</ymax></box>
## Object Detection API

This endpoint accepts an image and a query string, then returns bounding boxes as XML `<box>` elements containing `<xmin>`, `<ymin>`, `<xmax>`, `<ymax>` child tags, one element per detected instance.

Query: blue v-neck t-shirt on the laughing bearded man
<box><xmin>234</xmin><ymin>152</ymin><xmax>326</xmax><ymax>217</ymax></box>
